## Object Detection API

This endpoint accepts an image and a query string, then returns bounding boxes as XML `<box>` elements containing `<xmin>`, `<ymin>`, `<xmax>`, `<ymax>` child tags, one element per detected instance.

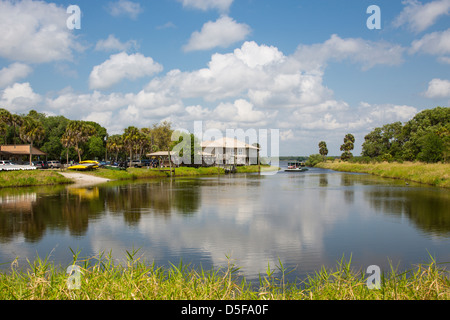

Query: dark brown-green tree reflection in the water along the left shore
<box><xmin>0</xmin><ymin>179</ymin><xmax>200</xmax><ymax>243</ymax></box>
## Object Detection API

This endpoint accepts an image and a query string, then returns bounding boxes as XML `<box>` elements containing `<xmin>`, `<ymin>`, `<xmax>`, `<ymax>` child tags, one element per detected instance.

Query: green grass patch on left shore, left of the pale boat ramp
<box><xmin>0</xmin><ymin>170</ymin><xmax>72</xmax><ymax>188</ymax></box>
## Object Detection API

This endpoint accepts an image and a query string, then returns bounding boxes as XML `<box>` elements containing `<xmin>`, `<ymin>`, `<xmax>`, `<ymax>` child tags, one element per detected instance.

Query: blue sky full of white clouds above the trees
<box><xmin>0</xmin><ymin>0</ymin><xmax>450</xmax><ymax>156</ymax></box>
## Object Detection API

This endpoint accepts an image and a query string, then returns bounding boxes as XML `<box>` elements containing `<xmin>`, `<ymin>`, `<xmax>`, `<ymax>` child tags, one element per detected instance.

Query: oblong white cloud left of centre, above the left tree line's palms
<box><xmin>89</xmin><ymin>52</ymin><xmax>162</xmax><ymax>89</ymax></box>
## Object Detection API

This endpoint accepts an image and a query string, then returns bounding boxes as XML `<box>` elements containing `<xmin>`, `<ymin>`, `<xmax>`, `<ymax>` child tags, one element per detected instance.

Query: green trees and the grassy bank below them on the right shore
<box><xmin>306</xmin><ymin>107</ymin><xmax>450</xmax><ymax>188</ymax></box>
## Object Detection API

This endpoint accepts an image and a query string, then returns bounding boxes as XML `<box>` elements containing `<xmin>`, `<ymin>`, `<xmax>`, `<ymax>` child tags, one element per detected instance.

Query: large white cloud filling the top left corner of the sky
<box><xmin>0</xmin><ymin>0</ymin><xmax>82</xmax><ymax>63</ymax></box>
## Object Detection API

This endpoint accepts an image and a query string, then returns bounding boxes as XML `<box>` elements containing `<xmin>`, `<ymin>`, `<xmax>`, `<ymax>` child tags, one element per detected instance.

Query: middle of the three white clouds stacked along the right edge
<box><xmin>409</xmin><ymin>29</ymin><xmax>450</xmax><ymax>62</ymax></box>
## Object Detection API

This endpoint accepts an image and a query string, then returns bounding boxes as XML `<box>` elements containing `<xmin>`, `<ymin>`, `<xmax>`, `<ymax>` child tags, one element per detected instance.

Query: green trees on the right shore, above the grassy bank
<box><xmin>307</xmin><ymin>107</ymin><xmax>450</xmax><ymax>166</ymax></box>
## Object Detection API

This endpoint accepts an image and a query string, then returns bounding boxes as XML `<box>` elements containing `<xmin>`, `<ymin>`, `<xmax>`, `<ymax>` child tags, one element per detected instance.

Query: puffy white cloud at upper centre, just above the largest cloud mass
<box><xmin>183</xmin><ymin>16</ymin><xmax>251</xmax><ymax>51</ymax></box>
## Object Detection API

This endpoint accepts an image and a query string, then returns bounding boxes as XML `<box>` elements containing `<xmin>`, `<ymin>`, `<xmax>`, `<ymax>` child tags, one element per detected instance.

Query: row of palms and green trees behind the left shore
<box><xmin>0</xmin><ymin>108</ymin><xmax>173</xmax><ymax>163</ymax></box>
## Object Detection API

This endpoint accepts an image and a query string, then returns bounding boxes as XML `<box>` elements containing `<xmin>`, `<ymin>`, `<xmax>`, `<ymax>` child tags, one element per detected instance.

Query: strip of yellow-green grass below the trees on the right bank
<box><xmin>316</xmin><ymin>160</ymin><xmax>450</xmax><ymax>188</ymax></box>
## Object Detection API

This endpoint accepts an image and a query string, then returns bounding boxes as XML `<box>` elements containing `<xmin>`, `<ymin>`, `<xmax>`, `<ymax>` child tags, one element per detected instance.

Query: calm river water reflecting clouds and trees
<box><xmin>0</xmin><ymin>168</ymin><xmax>450</xmax><ymax>280</ymax></box>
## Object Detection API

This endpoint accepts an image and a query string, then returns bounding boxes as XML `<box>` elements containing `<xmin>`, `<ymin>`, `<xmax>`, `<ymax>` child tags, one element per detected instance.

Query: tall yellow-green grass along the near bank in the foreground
<box><xmin>0</xmin><ymin>252</ymin><xmax>450</xmax><ymax>300</ymax></box>
